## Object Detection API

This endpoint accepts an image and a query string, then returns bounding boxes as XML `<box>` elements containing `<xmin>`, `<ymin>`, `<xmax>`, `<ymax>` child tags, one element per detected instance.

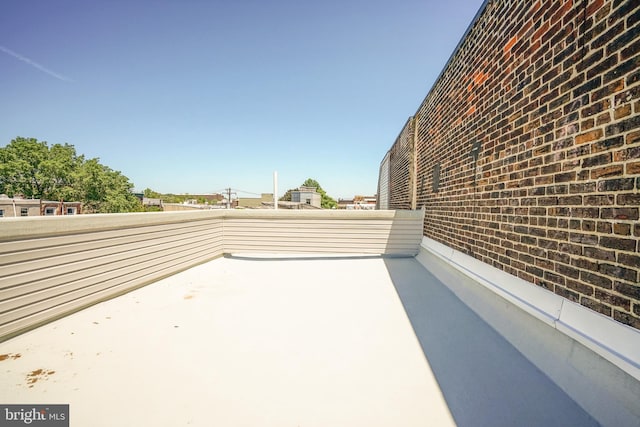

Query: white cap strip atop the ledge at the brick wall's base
<box><xmin>418</xmin><ymin>237</ymin><xmax>640</xmax><ymax>380</ymax></box>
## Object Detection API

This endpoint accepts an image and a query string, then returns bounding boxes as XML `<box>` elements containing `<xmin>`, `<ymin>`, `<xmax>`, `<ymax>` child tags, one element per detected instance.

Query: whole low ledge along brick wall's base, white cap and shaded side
<box><xmin>416</xmin><ymin>238</ymin><xmax>640</xmax><ymax>427</ymax></box>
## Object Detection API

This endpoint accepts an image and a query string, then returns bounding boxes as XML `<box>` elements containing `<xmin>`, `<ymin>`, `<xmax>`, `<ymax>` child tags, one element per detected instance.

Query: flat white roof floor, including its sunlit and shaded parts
<box><xmin>0</xmin><ymin>256</ymin><xmax>596</xmax><ymax>427</ymax></box>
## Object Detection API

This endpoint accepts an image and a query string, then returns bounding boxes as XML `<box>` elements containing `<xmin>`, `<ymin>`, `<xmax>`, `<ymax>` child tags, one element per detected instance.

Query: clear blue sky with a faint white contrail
<box><xmin>0</xmin><ymin>0</ymin><xmax>483</xmax><ymax>199</ymax></box>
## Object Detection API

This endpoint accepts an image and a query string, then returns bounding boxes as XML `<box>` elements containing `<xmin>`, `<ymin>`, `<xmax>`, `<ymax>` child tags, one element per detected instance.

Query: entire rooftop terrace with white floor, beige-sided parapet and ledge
<box><xmin>0</xmin><ymin>211</ymin><xmax>640</xmax><ymax>426</ymax></box>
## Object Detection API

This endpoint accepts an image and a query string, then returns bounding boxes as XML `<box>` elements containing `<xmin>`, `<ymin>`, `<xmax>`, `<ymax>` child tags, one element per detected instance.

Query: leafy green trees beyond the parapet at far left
<box><xmin>0</xmin><ymin>137</ymin><xmax>142</xmax><ymax>213</ymax></box>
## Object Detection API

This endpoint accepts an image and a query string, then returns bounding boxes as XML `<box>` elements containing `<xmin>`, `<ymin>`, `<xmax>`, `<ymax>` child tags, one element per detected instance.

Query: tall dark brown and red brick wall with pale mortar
<box><xmin>382</xmin><ymin>0</ymin><xmax>640</xmax><ymax>329</ymax></box>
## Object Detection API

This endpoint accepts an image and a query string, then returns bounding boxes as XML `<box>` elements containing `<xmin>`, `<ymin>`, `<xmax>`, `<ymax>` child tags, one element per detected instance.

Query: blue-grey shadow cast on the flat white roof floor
<box><xmin>385</xmin><ymin>258</ymin><xmax>598</xmax><ymax>427</ymax></box>
